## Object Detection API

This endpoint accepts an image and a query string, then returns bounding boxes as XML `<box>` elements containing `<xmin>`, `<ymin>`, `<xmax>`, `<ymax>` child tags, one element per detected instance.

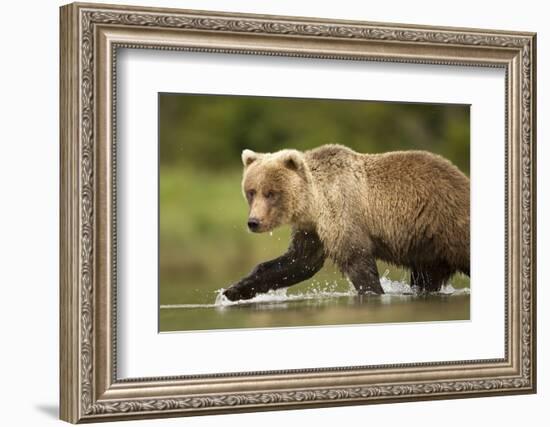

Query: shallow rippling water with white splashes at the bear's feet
<box><xmin>159</xmin><ymin>277</ymin><xmax>470</xmax><ymax>332</ymax></box>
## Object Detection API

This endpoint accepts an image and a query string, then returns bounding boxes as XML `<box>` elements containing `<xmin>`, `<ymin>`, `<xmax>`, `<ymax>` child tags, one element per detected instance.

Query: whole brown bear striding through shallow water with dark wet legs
<box><xmin>223</xmin><ymin>144</ymin><xmax>470</xmax><ymax>301</ymax></box>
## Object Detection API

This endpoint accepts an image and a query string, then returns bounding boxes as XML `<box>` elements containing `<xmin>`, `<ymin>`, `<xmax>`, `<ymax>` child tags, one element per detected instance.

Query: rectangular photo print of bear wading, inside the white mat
<box><xmin>158</xmin><ymin>93</ymin><xmax>470</xmax><ymax>332</ymax></box>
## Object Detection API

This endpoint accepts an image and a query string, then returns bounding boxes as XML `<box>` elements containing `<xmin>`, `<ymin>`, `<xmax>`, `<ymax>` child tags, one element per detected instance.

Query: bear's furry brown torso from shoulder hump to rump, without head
<box><xmin>305</xmin><ymin>145</ymin><xmax>470</xmax><ymax>272</ymax></box>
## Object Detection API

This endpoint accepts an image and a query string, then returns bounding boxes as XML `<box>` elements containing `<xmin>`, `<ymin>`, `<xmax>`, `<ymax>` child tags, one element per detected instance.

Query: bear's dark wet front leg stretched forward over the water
<box><xmin>223</xmin><ymin>230</ymin><xmax>326</xmax><ymax>301</ymax></box>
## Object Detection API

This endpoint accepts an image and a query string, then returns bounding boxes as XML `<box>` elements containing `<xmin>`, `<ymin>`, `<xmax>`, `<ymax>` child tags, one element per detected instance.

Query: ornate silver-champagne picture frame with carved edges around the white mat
<box><xmin>60</xmin><ymin>4</ymin><xmax>536</xmax><ymax>423</ymax></box>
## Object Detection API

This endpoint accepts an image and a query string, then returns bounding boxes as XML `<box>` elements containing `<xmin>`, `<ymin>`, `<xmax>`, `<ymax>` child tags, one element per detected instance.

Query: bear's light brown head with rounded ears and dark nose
<box><xmin>242</xmin><ymin>150</ymin><xmax>311</xmax><ymax>233</ymax></box>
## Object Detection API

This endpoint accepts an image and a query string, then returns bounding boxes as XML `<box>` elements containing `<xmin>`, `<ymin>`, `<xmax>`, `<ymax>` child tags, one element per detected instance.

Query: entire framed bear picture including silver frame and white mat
<box><xmin>59</xmin><ymin>3</ymin><xmax>537</xmax><ymax>423</ymax></box>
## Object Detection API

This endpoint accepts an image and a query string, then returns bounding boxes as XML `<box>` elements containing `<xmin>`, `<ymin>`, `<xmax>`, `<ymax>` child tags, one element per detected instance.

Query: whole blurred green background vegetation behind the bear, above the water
<box><xmin>159</xmin><ymin>94</ymin><xmax>470</xmax><ymax>324</ymax></box>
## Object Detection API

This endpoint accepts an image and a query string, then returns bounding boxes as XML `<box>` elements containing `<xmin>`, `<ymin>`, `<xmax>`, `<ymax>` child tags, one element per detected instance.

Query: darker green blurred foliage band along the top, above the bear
<box><xmin>159</xmin><ymin>94</ymin><xmax>470</xmax><ymax>173</ymax></box>
